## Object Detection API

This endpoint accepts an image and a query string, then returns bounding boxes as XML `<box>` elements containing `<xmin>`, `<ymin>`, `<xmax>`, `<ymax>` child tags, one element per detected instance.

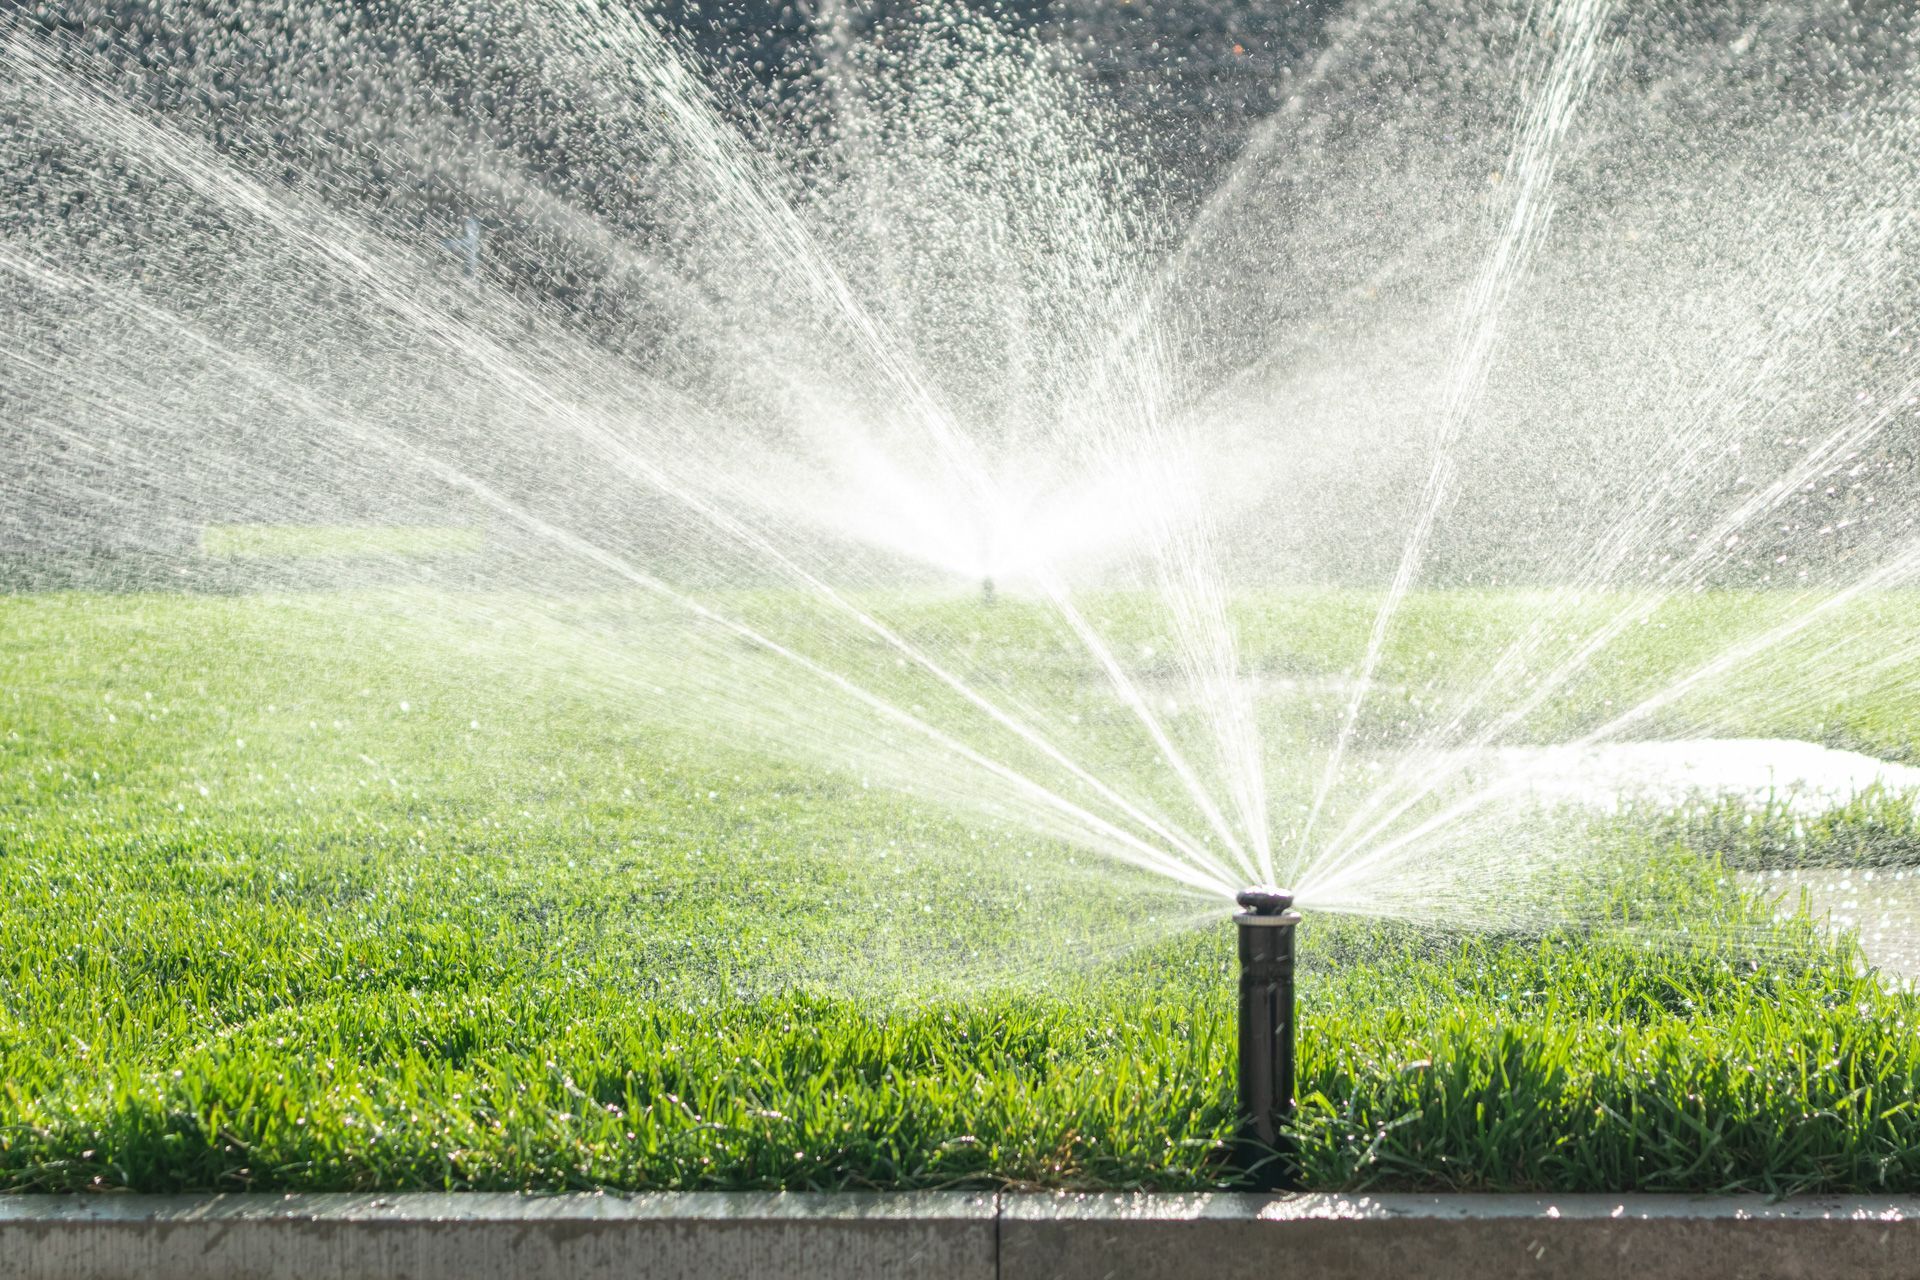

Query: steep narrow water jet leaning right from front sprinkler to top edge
<box><xmin>1296</xmin><ymin>0</ymin><xmax>1613</xmax><ymax>867</ymax></box>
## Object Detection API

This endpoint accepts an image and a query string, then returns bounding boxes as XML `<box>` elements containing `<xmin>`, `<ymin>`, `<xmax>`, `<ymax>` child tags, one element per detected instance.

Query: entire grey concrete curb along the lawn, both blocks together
<box><xmin>0</xmin><ymin>1192</ymin><xmax>1920</xmax><ymax>1280</ymax></box>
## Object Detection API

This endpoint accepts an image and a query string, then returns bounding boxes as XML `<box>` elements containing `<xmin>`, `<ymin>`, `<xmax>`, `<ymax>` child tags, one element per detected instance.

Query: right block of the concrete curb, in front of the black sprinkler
<box><xmin>1000</xmin><ymin>1196</ymin><xmax>1920</xmax><ymax>1280</ymax></box>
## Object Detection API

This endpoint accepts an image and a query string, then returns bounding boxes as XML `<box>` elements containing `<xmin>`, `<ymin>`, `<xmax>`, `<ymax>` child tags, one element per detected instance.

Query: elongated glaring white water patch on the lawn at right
<box><xmin>1471</xmin><ymin>737</ymin><xmax>1920</xmax><ymax>814</ymax></box>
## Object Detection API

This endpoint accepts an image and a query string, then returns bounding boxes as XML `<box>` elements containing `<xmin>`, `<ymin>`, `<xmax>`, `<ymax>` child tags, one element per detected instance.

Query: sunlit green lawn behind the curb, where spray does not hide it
<box><xmin>0</xmin><ymin>595</ymin><xmax>1920</xmax><ymax>1192</ymax></box>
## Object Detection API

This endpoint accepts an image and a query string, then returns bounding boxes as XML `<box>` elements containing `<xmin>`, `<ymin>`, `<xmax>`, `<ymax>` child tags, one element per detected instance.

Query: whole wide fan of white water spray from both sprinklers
<box><xmin>0</xmin><ymin>0</ymin><xmax>1920</xmax><ymax>948</ymax></box>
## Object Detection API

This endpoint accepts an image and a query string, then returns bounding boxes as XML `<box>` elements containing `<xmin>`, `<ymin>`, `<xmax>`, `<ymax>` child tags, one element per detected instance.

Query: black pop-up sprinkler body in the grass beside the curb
<box><xmin>1233</xmin><ymin>887</ymin><xmax>1300</xmax><ymax>1192</ymax></box>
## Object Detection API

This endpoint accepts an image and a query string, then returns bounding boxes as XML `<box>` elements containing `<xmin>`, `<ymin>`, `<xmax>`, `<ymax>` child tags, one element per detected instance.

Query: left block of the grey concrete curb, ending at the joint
<box><xmin>0</xmin><ymin>1194</ymin><xmax>996</xmax><ymax>1280</ymax></box>
